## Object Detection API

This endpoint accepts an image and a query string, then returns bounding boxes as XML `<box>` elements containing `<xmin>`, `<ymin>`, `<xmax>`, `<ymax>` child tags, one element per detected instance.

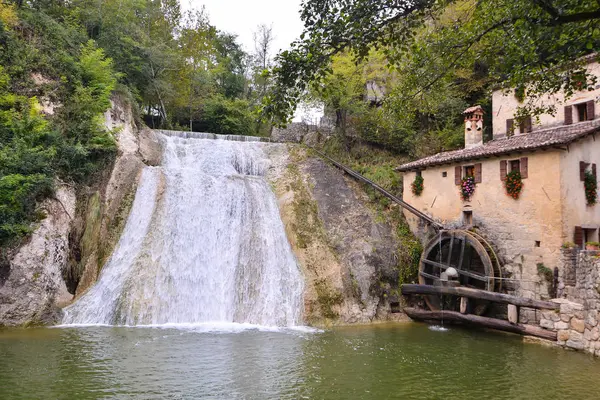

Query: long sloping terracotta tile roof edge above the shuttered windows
<box><xmin>397</xmin><ymin>119</ymin><xmax>600</xmax><ymax>171</ymax></box>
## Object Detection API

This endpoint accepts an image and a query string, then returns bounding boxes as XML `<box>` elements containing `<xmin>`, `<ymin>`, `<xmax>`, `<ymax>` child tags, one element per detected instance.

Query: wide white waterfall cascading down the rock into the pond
<box><xmin>63</xmin><ymin>132</ymin><xmax>303</xmax><ymax>326</ymax></box>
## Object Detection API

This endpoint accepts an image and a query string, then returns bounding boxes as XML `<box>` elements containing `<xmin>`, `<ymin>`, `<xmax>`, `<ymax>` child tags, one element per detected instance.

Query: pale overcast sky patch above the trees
<box><xmin>180</xmin><ymin>0</ymin><xmax>302</xmax><ymax>54</ymax></box>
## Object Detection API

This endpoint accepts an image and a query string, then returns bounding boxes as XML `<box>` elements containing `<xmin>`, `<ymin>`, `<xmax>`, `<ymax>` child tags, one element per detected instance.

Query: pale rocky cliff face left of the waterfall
<box><xmin>0</xmin><ymin>99</ymin><xmax>161</xmax><ymax>326</ymax></box>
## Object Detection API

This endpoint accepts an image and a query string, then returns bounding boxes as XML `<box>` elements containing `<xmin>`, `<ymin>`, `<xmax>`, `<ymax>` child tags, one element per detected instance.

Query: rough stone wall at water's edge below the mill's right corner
<box><xmin>540</xmin><ymin>249</ymin><xmax>600</xmax><ymax>356</ymax></box>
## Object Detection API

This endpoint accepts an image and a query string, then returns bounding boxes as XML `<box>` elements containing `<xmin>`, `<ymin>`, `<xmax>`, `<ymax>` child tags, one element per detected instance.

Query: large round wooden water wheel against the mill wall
<box><xmin>419</xmin><ymin>229</ymin><xmax>502</xmax><ymax>315</ymax></box>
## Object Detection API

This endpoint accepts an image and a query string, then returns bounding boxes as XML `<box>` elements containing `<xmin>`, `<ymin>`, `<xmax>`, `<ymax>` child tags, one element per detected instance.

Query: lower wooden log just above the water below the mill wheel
<box><xmin>404</xmin><ymin>307</ymin><xmax>557</xmax><ymax>341</ymax></box>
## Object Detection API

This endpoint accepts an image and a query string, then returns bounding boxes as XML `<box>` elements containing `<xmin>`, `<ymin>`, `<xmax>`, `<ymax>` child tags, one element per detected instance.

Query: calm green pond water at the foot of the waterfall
<box><xmin>0</xmin><ymin>323</ymin><xmax>600</xmax><ymax>400</ymax></box>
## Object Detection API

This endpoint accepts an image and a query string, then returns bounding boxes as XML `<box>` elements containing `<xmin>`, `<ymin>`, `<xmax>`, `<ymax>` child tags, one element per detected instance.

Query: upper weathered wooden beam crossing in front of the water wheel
<box><xmin>401</xmin><ymin>284</ymin><xmax>560</xmax><ymax>310</ymax></box>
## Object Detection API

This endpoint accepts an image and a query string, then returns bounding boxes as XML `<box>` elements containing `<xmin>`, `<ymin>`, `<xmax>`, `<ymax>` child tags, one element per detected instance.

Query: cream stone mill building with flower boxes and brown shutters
<box><xmin>398</xmin><ymin>59</ymin><xmax>600</xmax><ymax>298</ymax></box>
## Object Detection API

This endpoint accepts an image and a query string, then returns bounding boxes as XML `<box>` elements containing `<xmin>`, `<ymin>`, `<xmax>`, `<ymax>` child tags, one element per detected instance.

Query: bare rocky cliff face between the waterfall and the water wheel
<box><xmin>273</xmin><ymin>146</ymin><xmax>406</xmax><ymax>325</ymax></box>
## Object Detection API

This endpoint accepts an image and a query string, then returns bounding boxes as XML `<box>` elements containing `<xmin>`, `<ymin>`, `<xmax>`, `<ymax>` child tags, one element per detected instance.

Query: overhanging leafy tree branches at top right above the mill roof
<box><xmin>263</xmin><ymin>0</ymin><xmax>600</xmax><ymax>122</ymax></box>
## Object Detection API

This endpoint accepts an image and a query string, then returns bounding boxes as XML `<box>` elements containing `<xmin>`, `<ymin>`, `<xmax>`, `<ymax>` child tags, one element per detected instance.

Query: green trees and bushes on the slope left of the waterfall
<box><xmin>0</xmin><ymin>0</ymin><xmax>269</xmax><ymax>245</ymax></box>
